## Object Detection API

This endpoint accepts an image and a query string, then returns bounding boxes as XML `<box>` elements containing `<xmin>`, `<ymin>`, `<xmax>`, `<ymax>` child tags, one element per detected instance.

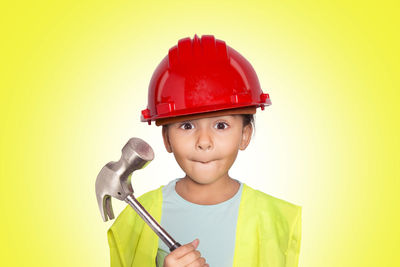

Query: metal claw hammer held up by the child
<box><xmin>96</xmin><ymin>137</ymin><xmax>181</xmax><ymax>252</ymax></box>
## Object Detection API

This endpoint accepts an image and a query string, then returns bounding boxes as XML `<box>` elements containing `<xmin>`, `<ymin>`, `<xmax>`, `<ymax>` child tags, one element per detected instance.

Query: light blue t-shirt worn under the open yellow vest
<box><xmin>157</xmin><ymin>179</ymin><xmax>243</xmax><ymax>267</ymax></box>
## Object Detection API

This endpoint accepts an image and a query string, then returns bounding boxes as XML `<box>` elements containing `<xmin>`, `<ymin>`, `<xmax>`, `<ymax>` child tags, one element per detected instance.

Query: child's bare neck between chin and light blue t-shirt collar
<box><xmin>175</xmin><ymin>176</ymin><xmax>240</xmax><ymax>205</ymax></box>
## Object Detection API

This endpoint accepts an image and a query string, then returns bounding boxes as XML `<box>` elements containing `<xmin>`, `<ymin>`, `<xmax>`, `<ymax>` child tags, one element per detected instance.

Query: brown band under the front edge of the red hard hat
<box><xmin>156</xmin><ymin>106</ymin><xmax>257</xmax><ymax>126</ymax></box>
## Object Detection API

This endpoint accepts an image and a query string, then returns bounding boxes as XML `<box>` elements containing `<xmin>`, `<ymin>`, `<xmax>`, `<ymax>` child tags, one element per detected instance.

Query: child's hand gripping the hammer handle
<box><xmin>164</xmin><ymin>239</ymin><xmax>210</xmax><ymax>267</ymax></box>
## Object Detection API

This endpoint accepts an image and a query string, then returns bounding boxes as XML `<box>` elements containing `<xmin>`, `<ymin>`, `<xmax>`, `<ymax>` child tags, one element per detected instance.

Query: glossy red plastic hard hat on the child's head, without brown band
<box><xmin>141</xmin><ymin>35</ymin><xmax>271</xmax><ymax>124</ymax></box>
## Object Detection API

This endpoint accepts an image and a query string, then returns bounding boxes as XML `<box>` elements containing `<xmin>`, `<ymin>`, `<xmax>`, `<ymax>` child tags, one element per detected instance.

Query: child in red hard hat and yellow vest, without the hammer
<box><xmin>108</xmin><ymin>35</ymin><xmax>301</xmax><ymax>267</ymax></box>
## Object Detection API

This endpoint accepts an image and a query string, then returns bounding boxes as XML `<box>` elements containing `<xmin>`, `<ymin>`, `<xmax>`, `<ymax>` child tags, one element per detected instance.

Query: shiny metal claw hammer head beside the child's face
<box><xmin>96</xmin><ymin>137</ymin><xmax>154</xmax><ymax>221</ymax></box>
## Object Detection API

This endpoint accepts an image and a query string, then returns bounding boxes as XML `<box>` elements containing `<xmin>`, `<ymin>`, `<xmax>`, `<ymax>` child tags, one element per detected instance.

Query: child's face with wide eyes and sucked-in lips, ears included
<box><xmin>163</xmin><ymin>115</ymin><xmax>252</xmax><ymax>184</ymax></box>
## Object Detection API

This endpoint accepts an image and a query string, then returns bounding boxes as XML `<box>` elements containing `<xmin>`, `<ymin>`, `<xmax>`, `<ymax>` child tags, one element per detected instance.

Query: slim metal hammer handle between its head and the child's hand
<box><xmin>125</xmin><ymin>194</ymin><xmax>181</xmax><ymax>252</ymax></box>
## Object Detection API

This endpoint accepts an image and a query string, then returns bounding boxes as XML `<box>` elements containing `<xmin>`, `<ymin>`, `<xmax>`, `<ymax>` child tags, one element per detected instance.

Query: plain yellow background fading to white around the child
<box><xmin>0</xmin><ymin>0</ymin><xmax>400</xmax><ymax>267</ymax></box>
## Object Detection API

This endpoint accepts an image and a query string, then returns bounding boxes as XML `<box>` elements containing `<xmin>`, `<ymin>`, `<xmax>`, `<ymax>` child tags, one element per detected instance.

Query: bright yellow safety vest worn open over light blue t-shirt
<box><xmin>107</xmin><ymin>184</ymin><xmax>301</xmax><ymax>267</ymax></box>
